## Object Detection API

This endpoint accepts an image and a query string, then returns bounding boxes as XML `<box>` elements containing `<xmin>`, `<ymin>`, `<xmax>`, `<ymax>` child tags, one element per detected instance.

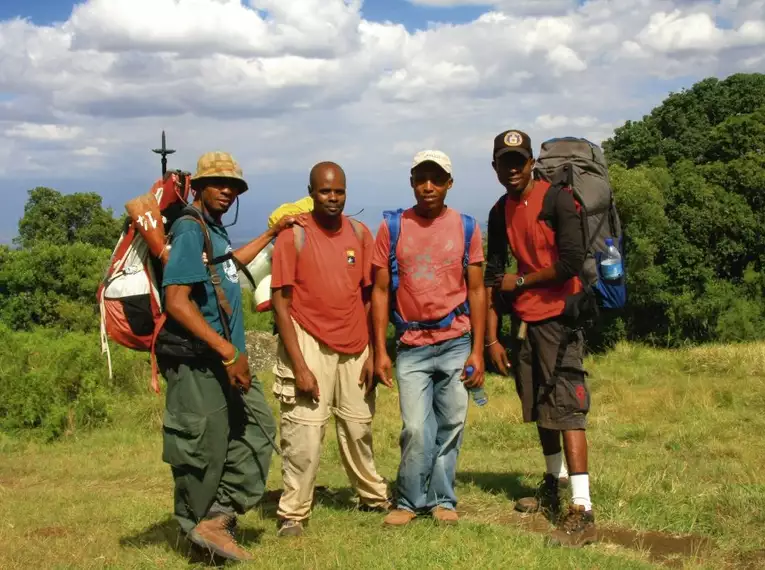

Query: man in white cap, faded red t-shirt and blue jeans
<box><xmin>372</xmin><ymin>150</ymin><xmax>486</xmax><ymax>526</ymax></box>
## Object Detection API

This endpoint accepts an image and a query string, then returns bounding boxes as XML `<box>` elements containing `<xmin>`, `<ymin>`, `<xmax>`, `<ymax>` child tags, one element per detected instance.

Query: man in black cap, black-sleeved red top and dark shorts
<box><xmin>484</xmin><ymin>130</ymin><xmax>595</xmax><ymax>546</ymax></box>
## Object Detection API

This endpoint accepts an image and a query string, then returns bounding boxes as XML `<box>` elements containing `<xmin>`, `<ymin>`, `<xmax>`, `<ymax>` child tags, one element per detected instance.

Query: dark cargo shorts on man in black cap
<box><xmin>510</xmin><ymin>318</ymin><xmax>590</xmax><ymax>431</ymax></box>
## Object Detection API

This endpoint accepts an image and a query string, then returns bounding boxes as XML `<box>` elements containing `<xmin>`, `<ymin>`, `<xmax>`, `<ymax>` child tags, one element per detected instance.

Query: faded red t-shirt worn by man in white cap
<box><xmin>372</xmin><ymin>208</ymin><xmax>483</xmax><ymax>346</ymax></box>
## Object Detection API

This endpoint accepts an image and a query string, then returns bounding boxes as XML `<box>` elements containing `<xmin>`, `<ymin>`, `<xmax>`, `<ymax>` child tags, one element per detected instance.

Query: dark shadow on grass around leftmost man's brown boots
<box><xmin>120</xmin><ymin>516</ymin><xmax>265</xmax><ymax>567</ymax></box>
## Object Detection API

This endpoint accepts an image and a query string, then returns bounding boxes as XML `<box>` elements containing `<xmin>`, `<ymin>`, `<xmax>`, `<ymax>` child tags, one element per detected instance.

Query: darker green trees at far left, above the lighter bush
<box><xmin>0</xmin><ymin>187</ymin><xmax>122</xmax><ymax>331</ymax></box>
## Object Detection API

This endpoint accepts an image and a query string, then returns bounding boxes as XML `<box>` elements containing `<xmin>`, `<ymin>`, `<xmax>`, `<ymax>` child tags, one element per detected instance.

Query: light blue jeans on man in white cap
<box><xmin>396</xmin><ymin>335</ymin><xmax>471</xmax><ymax>512</ymax></box>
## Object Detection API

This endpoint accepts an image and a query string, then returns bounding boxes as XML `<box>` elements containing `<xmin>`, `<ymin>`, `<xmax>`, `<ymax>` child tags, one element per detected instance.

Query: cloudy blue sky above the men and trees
<box><xmin>0</xmin><ymin>0</ymin><xmax>765</xmax><ymax>243</ymax></box>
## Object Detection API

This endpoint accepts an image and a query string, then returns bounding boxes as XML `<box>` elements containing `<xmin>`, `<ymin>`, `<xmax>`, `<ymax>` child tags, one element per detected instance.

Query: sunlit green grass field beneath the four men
<box><xmin>0</xmin><ymin>344</ymin><xmax>765</xmax><ymax>570</ymax></box>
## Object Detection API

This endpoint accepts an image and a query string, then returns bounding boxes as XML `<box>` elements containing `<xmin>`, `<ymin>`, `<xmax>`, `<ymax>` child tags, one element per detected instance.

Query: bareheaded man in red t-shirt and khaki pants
<box><xmin>271</xmin><ymin>162</ymin><xmax>390</xmax><ymax>536</ymax></box>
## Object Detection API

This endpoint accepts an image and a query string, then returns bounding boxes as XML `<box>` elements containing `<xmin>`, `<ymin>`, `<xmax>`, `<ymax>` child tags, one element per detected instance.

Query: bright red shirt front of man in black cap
<box><xmin>505</xmin><ymin>180</ymin><xmax>582</xmax><ymax>323</ymax></box>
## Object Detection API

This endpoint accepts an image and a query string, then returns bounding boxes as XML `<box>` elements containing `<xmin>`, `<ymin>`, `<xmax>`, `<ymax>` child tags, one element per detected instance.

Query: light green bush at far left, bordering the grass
<box><xmin>0</xmin><ymin>325</ymin><xmax>151</xmax><ymax>440</ymax></box>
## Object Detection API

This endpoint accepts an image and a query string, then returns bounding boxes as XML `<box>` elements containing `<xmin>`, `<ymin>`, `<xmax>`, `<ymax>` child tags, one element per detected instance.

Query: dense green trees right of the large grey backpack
<box><xmin>604</xmin><ymin>74</ymin><xmax>765</xmax><ymax>345</ymax></box>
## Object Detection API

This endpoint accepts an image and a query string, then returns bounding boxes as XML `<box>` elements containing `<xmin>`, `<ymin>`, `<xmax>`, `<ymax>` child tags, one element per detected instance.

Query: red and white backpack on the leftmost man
<box><xmin>97</xmin><ymin>171</ymin><xmax>194</xmax><ymax>392</ymax></box>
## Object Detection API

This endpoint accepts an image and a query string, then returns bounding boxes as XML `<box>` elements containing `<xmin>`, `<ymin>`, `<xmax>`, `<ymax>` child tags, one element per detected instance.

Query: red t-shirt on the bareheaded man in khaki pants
<box><xmin>271</xmin><ymin>216</ymin><xmax>374</xmax><ymax>354</ymax></box>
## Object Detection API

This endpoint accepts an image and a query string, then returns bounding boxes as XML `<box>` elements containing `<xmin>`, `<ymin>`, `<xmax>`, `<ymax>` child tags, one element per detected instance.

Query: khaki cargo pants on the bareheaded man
<box><xmin>273</xmin><ymin>320</ymin><xmax>388</xmax><ymax>521</ymax></box>
